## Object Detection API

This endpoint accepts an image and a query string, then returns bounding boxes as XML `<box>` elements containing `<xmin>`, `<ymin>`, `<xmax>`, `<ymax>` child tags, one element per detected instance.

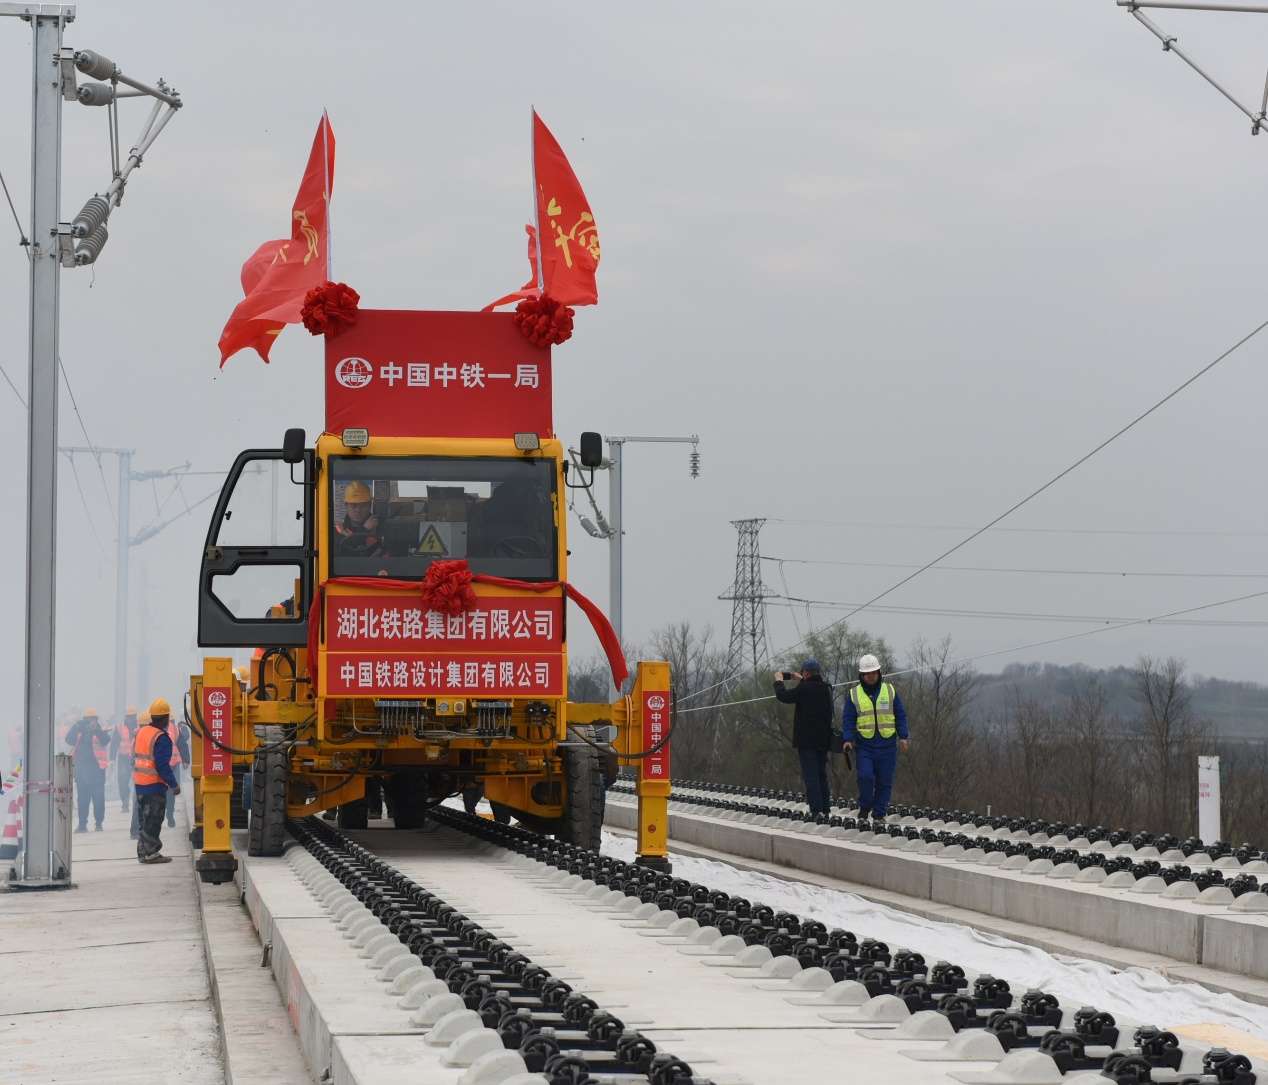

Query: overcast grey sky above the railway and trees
<box><xmin>0</xmin><ymin>0</ymin><xmax>1268</xmax><ymax>721</ymax></box>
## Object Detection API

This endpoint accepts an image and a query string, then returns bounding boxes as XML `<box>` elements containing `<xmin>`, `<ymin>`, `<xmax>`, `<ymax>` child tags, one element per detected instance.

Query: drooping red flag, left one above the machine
<box><xmin>221</xmin><ymin>113</ymin><xmax>335</xmax><ymax>366</ymax></box>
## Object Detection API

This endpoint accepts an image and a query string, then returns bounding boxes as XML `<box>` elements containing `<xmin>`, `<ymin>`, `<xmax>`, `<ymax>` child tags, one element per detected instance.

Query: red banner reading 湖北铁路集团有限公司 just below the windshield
<box><xmin>326</xmin><ymin>594</ymin><xmax>563</xmax><ymax>653</ymax></box>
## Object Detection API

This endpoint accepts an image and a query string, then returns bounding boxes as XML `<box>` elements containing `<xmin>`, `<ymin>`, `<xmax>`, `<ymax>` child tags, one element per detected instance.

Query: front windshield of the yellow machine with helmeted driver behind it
<box><xmin>330</xmin><ymin>456</ymin><xmax>558</xmax><ymax>581</ymax></box>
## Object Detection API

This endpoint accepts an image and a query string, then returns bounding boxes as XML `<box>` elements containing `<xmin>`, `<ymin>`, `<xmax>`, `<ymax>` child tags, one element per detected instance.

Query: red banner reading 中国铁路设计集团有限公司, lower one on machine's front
<box><xmin>325</xmin><ymin>652</ymin><xmax>563</xmax><ymax>697</ymax></box>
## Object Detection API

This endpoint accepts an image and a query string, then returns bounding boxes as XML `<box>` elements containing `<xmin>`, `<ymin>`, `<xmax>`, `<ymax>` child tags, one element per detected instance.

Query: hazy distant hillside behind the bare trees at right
<box><xmin>974</xmin><ymin>663</ymin><xmax>1268</xmax><ymax>740</ymax></box>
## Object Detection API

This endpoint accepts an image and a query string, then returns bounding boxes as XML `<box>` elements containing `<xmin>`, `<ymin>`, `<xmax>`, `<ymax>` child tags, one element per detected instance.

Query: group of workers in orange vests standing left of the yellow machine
<box><xmin>65</xmin><ymin>697</ymin><xmax>191</xmax><ymax>863</ymax></box>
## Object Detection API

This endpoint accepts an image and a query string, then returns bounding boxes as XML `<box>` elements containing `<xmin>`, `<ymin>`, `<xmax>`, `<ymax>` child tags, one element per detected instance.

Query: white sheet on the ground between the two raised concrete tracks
<box><xmin>602</xmin><ymin>830</ymin><xmax>1268</xmax><ymax>1039</ymax></box>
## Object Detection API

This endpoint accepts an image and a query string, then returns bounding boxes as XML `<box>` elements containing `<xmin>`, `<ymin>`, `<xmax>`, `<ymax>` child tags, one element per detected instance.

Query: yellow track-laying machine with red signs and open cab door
<box><xmin>186</xmin><ymin>311</ymin><xmax>672</xmax><ymax>882</ymax></box>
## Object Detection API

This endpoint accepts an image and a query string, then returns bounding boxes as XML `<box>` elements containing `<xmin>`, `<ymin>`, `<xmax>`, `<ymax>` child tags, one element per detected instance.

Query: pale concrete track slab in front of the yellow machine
<box><xmin>243</xmin><ymin>830</ymin><xmax>1034</xmax><ymax>1085</ymax></box>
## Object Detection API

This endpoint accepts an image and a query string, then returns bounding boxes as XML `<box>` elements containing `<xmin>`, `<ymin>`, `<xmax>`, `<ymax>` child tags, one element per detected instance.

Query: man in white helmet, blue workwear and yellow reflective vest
<box><xmin>841</xmin><ymin>654</ymin><xmax>908</xmax><ymax>820</ymax></box>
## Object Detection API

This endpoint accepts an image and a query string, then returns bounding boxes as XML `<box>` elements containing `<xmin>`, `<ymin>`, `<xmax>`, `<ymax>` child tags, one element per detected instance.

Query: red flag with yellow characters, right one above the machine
<box><xmin>486</xmin><ymin>110</ymin><xmax>600</xmax><ymax>309</ymax></box>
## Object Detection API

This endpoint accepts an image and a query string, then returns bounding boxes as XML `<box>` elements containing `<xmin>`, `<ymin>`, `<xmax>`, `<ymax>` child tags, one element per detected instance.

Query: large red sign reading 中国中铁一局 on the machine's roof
<box><xmin>326</xmin><ymin>309</ymin><xmax>554</xmax><ymax>437</ymax></box>
